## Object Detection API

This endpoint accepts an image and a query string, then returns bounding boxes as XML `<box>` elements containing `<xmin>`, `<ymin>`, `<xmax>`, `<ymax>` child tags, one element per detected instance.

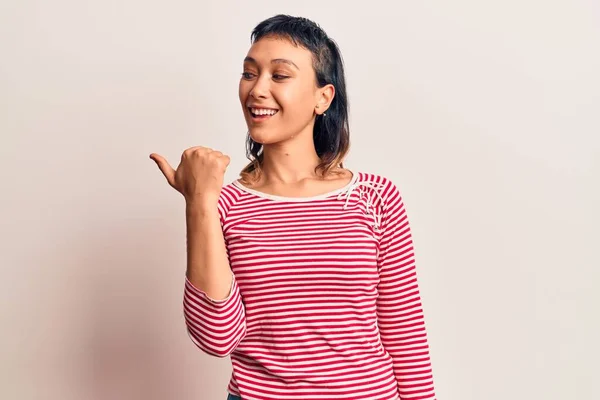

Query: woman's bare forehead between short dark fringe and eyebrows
<box><xmin>248</xmin><ymin>37</ymin><xmax>312</xmax><ymax>70</ymax></box>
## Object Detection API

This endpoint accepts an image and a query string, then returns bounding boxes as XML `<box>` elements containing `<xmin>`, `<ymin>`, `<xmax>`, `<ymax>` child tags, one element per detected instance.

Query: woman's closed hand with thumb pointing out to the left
<box><xmin>150</xmin><ymin>146</ymin><xmax>230</xmax><ymax>204</ymax></box>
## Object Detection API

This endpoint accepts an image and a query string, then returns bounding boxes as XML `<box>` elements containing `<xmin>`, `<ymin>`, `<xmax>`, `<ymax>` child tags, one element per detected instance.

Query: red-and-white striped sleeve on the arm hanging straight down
<box><xmin>377</xmin><ymin>181</ymin><xmax>435</xmax><ymax>400</ymax></box>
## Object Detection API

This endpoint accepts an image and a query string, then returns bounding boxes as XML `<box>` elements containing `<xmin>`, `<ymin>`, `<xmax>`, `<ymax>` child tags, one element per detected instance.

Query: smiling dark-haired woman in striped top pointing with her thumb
<box><xmin>151</xmin><ymin>15</ymin><xmax>435</xmax><ymax>400</ymax></box>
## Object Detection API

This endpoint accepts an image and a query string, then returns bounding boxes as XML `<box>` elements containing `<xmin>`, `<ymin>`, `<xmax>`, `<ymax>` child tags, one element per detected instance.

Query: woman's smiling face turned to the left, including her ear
<box><xmin>239</xmin><ymin>37</ymin><xmax>327</xmax><ymax>144</ymax></box>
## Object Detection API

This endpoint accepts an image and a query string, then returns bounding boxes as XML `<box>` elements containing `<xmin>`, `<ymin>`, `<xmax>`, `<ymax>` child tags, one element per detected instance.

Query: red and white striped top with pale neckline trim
<box><xmin>184</xmin><ymin>172</ymin><xmax>435</xmax><ymax>400</ymax></box>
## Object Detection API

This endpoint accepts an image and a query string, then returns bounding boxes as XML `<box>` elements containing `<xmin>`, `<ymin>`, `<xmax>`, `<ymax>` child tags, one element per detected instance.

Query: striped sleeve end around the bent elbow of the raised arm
<box><xmin>183</xmin><ymin>274</ymin><xmax>246</xmax><ymax>357</ymax></box>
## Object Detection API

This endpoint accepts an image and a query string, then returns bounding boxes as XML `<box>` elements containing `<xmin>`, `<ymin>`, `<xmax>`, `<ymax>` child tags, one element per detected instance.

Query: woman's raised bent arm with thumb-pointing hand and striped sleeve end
<box><xmin>150</xmin><ymin>146</ymin><xmax>246</xmax><ymax>357</ymax></box>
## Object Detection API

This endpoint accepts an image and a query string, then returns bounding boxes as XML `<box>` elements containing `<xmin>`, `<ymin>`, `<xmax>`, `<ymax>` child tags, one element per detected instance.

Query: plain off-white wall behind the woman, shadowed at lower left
<box><xmin>0</xmin><ymin>0</ymin><xmax>600</xmax><ymax>400</ymax></box>
